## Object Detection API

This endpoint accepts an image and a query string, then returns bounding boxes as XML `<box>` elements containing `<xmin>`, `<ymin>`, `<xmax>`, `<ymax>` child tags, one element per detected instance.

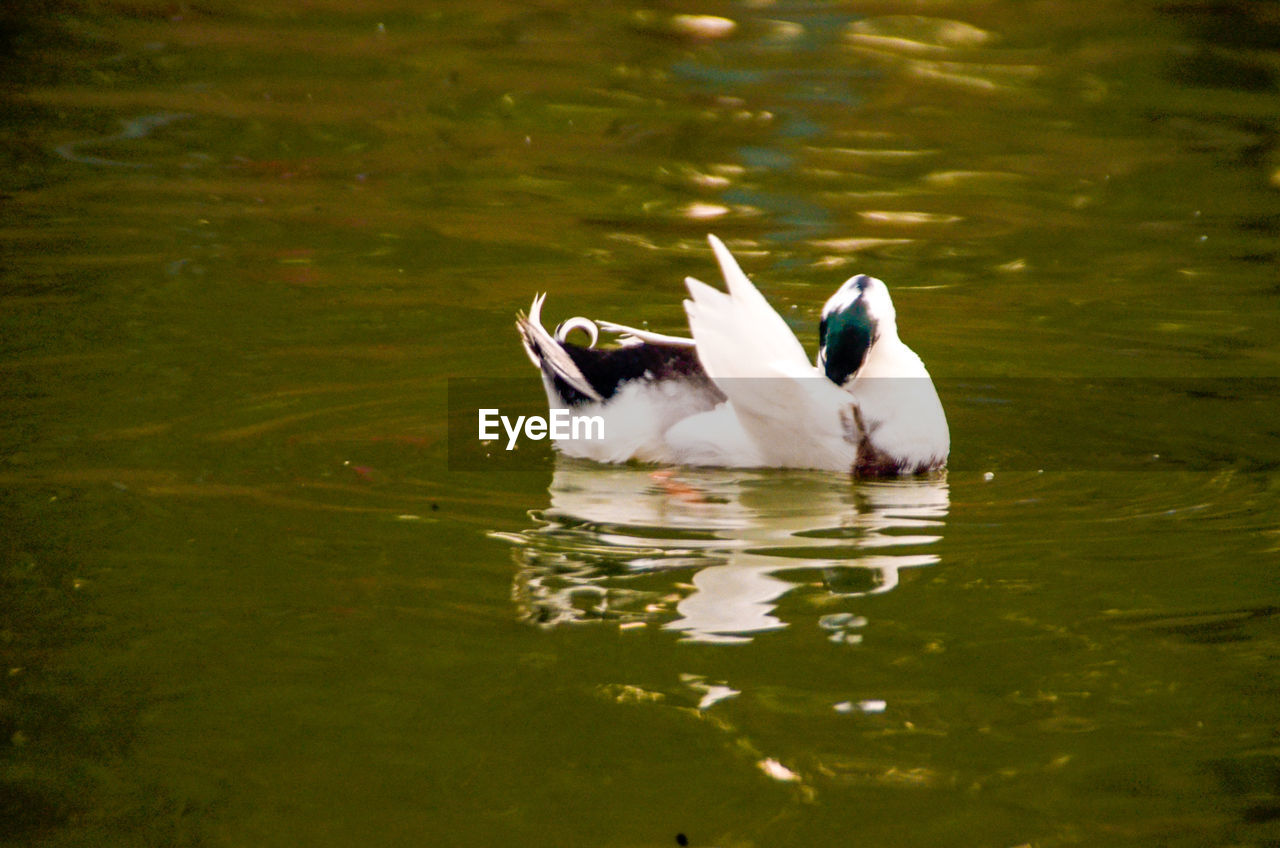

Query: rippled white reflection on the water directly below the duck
<box><xmin>494</xmin><ymin>460</ymin><xmax>950</xmax><ymax>642</ymax></box>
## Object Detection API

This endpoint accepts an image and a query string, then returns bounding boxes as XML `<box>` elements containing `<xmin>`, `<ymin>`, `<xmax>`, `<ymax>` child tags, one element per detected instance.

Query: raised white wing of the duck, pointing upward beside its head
<box><xmin>685</xmin><ymin>236</ymin><xmax>859</xmax><ymax>471</ymax></box>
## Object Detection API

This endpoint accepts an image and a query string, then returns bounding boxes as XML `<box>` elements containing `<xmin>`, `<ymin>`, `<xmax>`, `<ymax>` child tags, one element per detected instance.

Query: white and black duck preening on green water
<box><xmin>516</xmin><ymin>236</ymin><xmax>951</xmax><ymax>477</ymax></box>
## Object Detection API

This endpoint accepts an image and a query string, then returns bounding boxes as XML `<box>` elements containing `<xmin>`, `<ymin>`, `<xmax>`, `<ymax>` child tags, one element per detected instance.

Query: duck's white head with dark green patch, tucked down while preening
<box><xmin>818</xmin><ymin>274</ymin><xmax>897</xmax><ymax>386</ymax></box>
